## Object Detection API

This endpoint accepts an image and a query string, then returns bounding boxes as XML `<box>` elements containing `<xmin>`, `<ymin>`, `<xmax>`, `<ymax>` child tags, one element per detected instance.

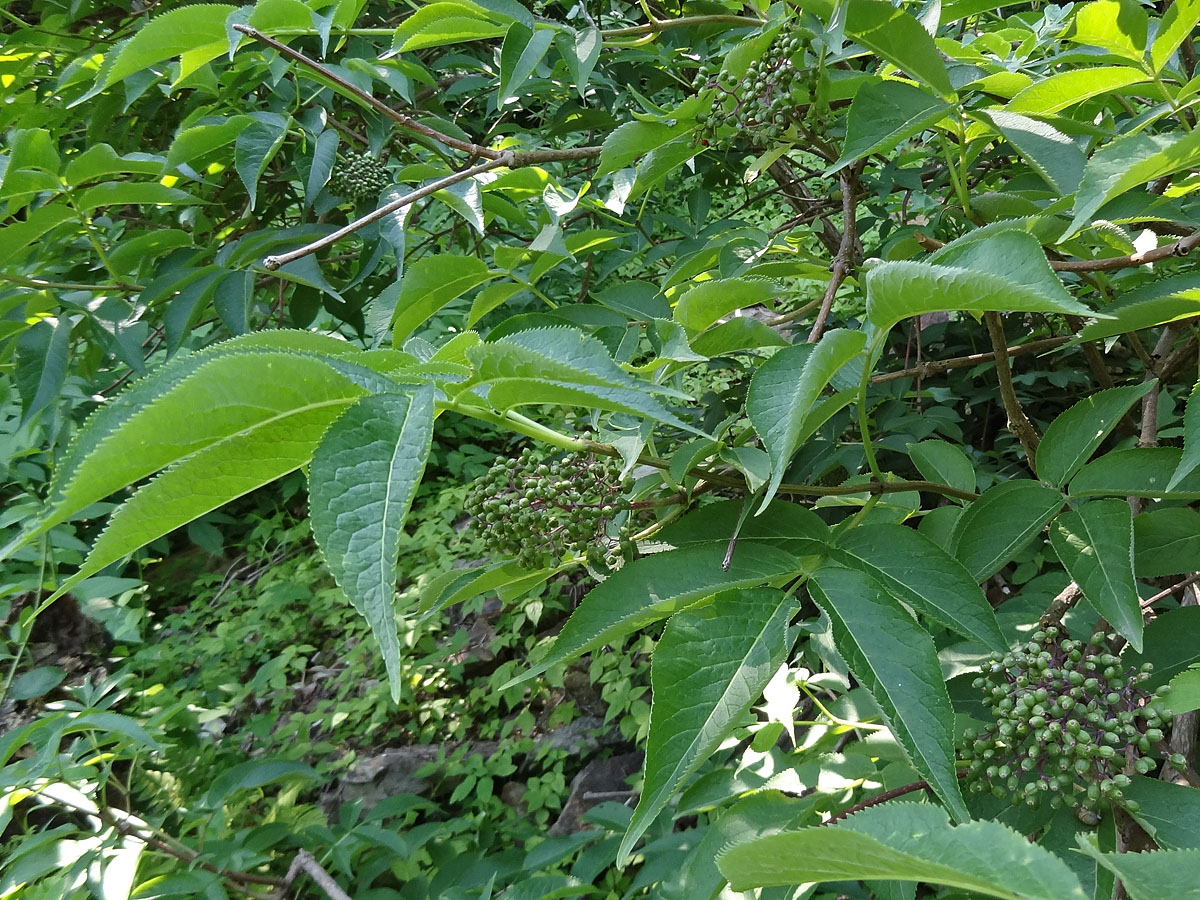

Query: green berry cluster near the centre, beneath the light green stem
<box><xmin>464</xmin><ymin>448</ymin><xmax>632</xmax><ymax>571</ymax></box>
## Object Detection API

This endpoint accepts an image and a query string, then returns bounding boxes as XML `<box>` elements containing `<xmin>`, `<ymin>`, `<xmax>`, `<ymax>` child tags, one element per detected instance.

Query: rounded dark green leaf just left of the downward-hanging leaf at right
<box><xmin>947</xmin><ymin>479</ymin><xmax>1066</xmax><ymax>583</ymax></box>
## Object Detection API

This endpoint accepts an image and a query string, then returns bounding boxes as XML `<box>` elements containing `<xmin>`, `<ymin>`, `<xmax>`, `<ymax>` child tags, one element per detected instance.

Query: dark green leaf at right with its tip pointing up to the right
<box><xmin>1036</xmin><ymin>380</ymin><xmax>1154</xmax><ymax>487</ymax></box>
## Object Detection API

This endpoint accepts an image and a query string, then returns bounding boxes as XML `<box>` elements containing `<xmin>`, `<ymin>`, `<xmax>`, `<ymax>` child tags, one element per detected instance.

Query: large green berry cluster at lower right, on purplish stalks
<box><xmin>961</xmin><ymin>626</ymin><xmax>1182</xmax><ymax>823</ymax></box>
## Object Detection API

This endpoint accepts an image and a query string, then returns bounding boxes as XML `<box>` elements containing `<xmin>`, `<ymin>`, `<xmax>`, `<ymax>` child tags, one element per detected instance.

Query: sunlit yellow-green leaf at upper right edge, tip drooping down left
<box><xmin>1063</xmin><ymin>131</ymin><xmax>1200</xmax><ymax>238</ymax></box>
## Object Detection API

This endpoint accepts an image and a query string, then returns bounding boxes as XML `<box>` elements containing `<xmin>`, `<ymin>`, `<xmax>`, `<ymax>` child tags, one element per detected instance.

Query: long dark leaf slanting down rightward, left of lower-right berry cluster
<box><xmin>805</xmin><ymin>565</ymin><xmax>971</xmax><ymax>825</ymax></box>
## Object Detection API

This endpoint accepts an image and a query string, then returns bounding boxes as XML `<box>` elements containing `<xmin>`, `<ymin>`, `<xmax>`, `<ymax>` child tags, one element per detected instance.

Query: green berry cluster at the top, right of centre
<box><xmin>694</xmin><ymin>25</ymin><xmax>812</xmax><ymax>144</ymax></box>
